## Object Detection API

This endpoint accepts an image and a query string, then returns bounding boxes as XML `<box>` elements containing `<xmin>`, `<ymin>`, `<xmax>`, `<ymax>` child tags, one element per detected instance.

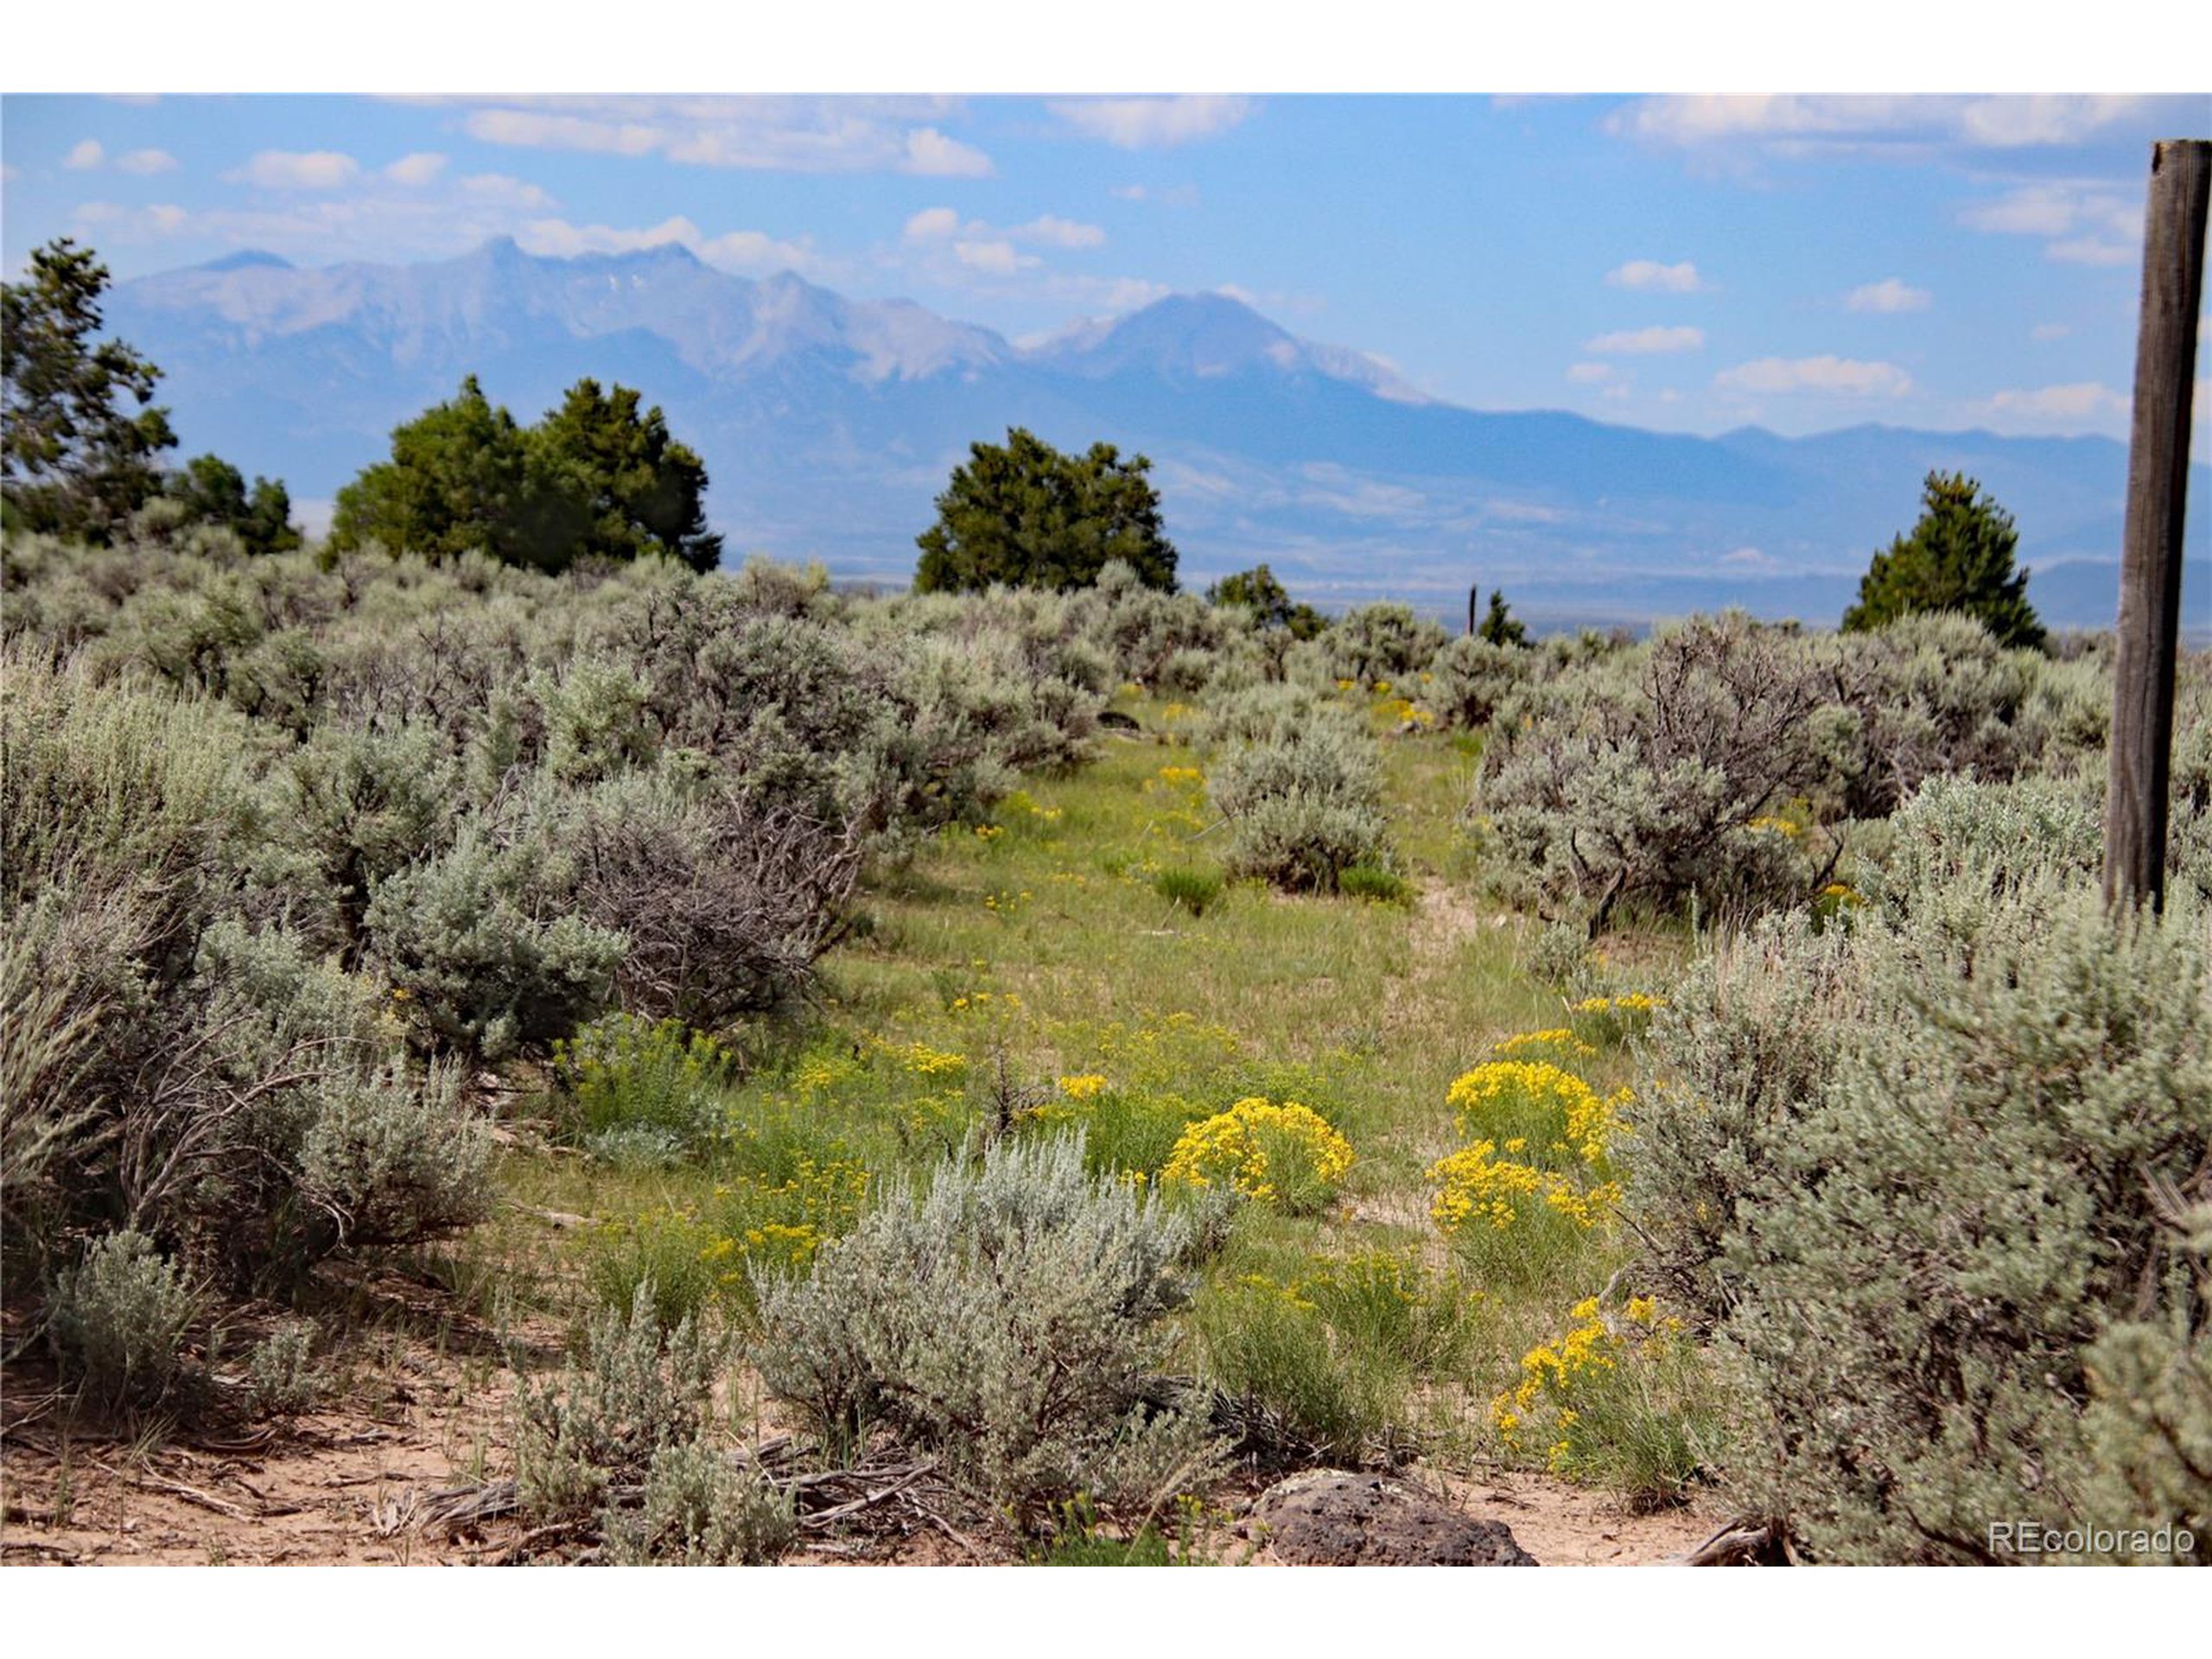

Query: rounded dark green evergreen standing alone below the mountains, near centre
<box><xmin>913</xmin><ymin>427</ymin><xmax>1174</xmax><ymax>593</ymax></box>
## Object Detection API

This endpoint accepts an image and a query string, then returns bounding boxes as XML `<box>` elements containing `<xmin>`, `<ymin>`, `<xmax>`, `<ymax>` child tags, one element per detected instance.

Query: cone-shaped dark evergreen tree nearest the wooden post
<box><xmin>1842</xmin><ymin>474</ymin><xmax>2044</xmax><ymax>648</ymax></box>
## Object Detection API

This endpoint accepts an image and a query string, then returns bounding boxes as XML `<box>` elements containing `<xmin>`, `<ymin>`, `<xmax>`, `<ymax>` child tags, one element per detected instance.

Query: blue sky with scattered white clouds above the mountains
<box><xmin>0</xmin><ymin>95</ymin><xmax>2212</xmax><ymax>454</ymax></box>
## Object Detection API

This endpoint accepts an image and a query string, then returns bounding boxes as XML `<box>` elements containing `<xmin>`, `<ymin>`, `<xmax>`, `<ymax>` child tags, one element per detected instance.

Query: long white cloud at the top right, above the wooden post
<box><xmin>1606</xmin><ymin>95</ymin><xmax>2158</xmax><ymax>150</ymax></box>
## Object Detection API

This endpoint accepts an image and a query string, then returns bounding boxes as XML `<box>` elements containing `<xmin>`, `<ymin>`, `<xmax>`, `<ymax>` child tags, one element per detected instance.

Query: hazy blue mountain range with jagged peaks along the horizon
<box><xmin>108</xmin><ymin>238</ymin><xmax>2212</xmax><ymax>626</ymax></box>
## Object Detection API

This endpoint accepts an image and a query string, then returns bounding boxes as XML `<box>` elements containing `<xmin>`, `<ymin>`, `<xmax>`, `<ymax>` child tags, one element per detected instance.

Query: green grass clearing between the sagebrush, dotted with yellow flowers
<box><xmin>474</xmin><ymin>702</ymin><xmax>1699</xmax><ymax>1503</ymax></box>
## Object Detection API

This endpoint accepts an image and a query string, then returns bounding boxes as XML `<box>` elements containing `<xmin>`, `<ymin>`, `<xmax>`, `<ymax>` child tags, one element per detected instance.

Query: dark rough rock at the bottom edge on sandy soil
<box><xmin>1252</xmin><ymin>1469</ymin><xmax>1537</xmax><ymax>1566</ymax></box>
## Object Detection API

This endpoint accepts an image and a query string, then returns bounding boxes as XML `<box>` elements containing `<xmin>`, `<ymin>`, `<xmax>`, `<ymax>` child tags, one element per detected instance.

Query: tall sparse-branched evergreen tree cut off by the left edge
<box><xmin>0</xmin><ymin>237</ymin><xmax>177</xmax><ymax>542</ymax></box>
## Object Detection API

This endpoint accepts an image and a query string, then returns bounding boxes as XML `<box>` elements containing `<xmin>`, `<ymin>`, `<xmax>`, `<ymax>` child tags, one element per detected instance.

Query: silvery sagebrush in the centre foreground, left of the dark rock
<box><xmin>754</xmin><ymin>1135</ymin><xmax>1208</xmax><ymax>1517</ymax></box>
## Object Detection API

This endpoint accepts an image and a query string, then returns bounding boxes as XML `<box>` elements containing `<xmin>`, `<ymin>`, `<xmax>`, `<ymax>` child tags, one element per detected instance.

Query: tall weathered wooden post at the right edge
<box><xmin>2104</xmin><ymin>139</ymin><xmax>2212</xmax><ymax>912</ymax></box>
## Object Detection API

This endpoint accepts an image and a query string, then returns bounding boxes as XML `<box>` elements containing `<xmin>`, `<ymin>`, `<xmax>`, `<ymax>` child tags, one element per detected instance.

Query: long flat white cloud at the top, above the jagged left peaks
<box><xmin>462</xmin><ymin>98</ymin><xmax>993</xmax><ymax>179</ymax></box>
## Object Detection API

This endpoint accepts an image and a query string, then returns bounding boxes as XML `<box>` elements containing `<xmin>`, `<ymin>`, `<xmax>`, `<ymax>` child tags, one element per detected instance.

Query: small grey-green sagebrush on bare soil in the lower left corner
<box><xmin>47</xmin><ymin>1232</ymin><xmax>201</xmax><ymax>1409</ymax></box>
